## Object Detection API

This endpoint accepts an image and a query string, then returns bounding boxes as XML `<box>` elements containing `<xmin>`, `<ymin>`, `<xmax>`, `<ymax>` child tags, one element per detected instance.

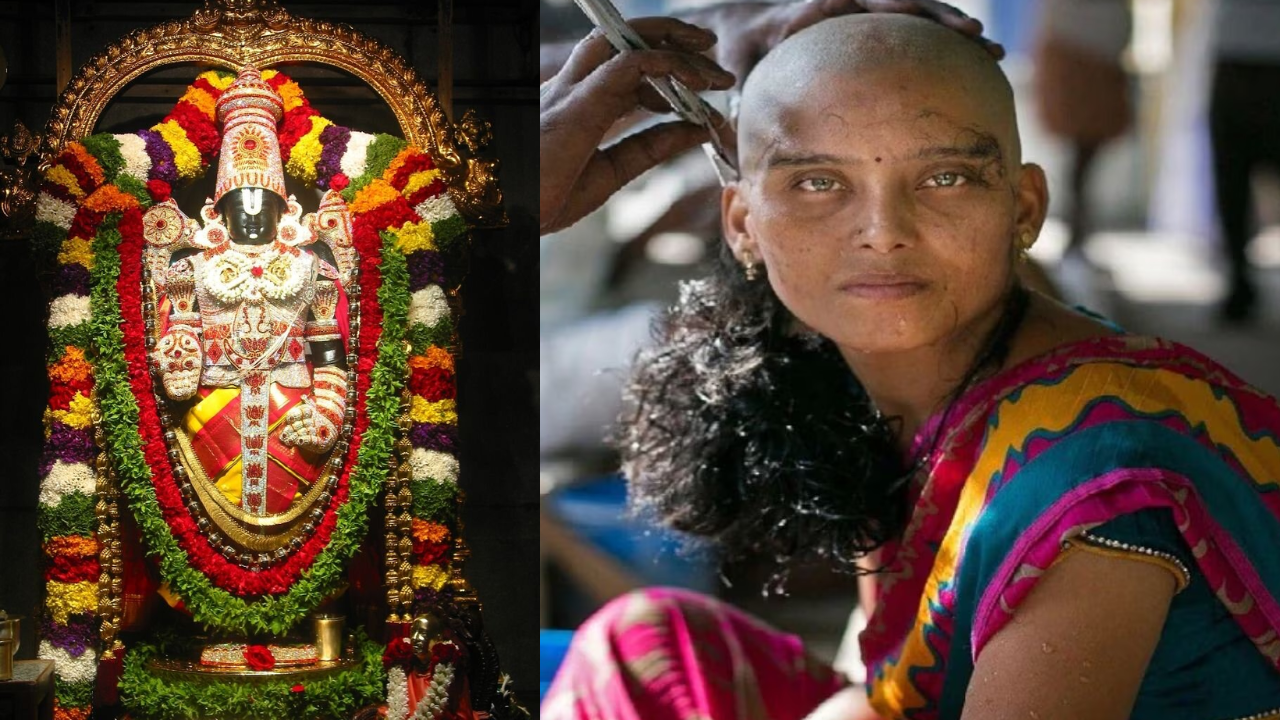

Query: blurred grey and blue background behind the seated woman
<box><xmin>539</xmin><ymin>0</ymin><xmax>1280</xmax><ymax>696</ymax></box>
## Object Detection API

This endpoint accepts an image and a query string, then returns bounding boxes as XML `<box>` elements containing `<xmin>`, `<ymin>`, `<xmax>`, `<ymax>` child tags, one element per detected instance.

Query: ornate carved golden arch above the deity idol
<box><xmin>40</xmin><ymin>0</ymin><xmax>507</xmax><ymax>228</ymax></box>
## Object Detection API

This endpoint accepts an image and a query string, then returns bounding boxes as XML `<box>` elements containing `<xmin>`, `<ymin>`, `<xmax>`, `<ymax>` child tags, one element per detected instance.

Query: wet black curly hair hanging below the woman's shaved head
<box><xmin>616</xmin><ymin>243</ymin><xmax>1027</xmax><ymax>585</ymax></box>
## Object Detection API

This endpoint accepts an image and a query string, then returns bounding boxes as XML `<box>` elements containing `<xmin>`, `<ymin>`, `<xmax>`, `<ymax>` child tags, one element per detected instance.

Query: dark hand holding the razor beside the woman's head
<box><xmin>538</xmin><ymin>18</ymin><xmax>733</xmax><ymax>234</ymax></box>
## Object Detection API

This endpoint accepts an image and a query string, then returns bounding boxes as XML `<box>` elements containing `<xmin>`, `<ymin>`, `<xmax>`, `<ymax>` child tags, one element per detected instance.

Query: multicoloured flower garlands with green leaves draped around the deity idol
<box><xmin>35</xmin><ymin>65</ymin><xmax>466</xmax><ymax>717</ymax></box>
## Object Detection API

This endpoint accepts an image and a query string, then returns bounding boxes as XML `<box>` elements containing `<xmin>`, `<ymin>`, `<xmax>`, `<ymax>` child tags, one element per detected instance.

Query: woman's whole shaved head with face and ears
<box><xmin>721</xmin><ymin>13</ymin><xmax>1048</xmax><ymax>372</ymax></box>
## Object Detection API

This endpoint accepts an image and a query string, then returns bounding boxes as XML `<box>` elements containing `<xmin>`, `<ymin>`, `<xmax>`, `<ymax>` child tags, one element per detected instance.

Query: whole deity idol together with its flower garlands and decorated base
<box><xmin>35</xmin><ymin>5</ymin><xmax>527</xmax><ymax>720</ymax></box>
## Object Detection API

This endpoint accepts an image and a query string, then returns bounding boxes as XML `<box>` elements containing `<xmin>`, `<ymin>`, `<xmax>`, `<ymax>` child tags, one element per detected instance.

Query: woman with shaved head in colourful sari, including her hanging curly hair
<box><xmin>543</xmin><ymin>9</ymin><xmax>1280</xmax><ymax>720</ymax></box>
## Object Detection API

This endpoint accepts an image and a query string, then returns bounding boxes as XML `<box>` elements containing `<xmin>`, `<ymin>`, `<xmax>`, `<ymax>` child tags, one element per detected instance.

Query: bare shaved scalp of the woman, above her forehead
<box><xmin>739</xmin><ymin>13</ymin><xmax>1021</xmax><ymax>170</ymax></box>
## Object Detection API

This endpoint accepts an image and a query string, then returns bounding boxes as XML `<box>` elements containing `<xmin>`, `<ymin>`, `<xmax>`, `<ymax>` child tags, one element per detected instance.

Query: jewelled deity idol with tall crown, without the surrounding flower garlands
<box><xmin>145</xmin><ymin>69</ymin><xmax>355</xmax><ymax>568</ymax></box>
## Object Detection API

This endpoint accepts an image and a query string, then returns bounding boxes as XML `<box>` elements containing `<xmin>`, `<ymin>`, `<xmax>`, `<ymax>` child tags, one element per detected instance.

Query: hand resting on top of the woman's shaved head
<box><xmin>682</xmin><ymin>0</ymin><xmax>1005</xmax><ymax>81</ymax></box>
